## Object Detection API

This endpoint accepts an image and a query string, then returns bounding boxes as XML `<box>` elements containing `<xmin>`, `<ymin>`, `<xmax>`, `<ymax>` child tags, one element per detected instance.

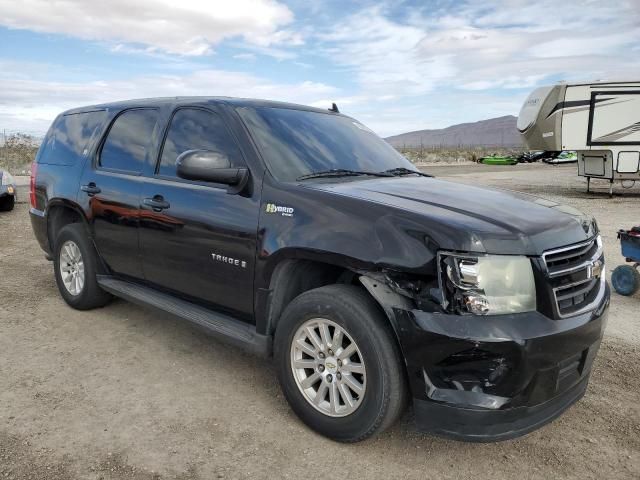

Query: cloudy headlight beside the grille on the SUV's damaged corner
<box><xmin>438</xmin><ymin>253</ymin><xmax>536</xmax><ymax>315</ymax></box>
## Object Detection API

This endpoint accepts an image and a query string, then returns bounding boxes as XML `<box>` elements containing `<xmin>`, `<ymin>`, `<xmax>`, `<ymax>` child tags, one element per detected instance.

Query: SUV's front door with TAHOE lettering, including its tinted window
<box><xmin>140</xmin><ymin>106</ymin><xmax>259</xmax><ymax>318</ymax></box>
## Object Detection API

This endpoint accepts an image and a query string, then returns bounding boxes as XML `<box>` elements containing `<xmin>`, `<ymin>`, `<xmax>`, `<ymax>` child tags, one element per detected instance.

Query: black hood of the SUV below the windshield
<box><xmin>305</xmin><ymin>176</ymin><xmax>597</xmax><ymax>255</ymax></box>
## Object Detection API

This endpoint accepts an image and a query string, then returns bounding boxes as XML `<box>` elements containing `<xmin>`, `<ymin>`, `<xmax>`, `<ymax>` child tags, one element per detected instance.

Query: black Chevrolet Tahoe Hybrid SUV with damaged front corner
<box><xmin>30</xmin><ymin>98</ymin><xmax>609</xmax><ymax>442</ymax></box>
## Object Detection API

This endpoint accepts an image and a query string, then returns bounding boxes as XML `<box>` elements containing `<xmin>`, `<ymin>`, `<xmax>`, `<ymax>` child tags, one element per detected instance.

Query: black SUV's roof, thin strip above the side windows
<box><xmin>63</xmin><ymin>97</ymin><xmax>335</xmax><ymax>115</ymax></box>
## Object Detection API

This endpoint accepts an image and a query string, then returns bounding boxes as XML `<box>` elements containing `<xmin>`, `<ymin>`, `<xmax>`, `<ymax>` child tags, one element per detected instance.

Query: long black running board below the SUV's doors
<box><xmin>96</xmin><ymin>275</ymin><xmax>272</xmax><ymax>357</ymax></box>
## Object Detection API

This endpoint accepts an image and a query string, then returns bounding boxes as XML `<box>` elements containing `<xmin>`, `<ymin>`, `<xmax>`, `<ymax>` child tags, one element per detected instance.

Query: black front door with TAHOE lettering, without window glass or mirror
<box><xmin>140</xmin><ymin>104</ymin><xmax>262</xmax><ymax>321</ymax></box>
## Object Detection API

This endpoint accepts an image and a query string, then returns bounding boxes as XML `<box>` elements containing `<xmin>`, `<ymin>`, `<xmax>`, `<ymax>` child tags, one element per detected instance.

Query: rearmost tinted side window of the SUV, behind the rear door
<box><xmin>36</xmin><ymin>110</ymin><xmax>107</xmax><ymax>165</ymax></box>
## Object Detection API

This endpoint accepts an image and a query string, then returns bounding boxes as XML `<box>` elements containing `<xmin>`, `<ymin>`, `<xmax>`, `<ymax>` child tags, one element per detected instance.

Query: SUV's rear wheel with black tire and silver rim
<box><xmin>53</xmin><ymin>223</ymin><xmax>112</xmax><ymax>310</ymax></box>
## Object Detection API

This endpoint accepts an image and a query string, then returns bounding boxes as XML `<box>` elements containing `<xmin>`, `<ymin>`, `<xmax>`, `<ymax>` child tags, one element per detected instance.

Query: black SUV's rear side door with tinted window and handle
<box><xmin>79</xmin><ymin>108</ymin><xmax>158</xmax><ymax>279</ymax></box>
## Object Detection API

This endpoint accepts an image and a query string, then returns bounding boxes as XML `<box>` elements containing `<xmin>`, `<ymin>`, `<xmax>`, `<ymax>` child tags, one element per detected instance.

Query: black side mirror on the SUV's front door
<box><xmin>176</xmin><ymin>150</ymin><xmax>249</xmax><ymax>192</ymax></box>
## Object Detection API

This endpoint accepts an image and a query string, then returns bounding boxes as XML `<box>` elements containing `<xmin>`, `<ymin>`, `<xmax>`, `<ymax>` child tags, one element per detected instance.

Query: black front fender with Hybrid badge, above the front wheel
<box><xmin>255</xmin><ymin>176</ymin><xmax>438</xmax><ymax>289</ymax></box>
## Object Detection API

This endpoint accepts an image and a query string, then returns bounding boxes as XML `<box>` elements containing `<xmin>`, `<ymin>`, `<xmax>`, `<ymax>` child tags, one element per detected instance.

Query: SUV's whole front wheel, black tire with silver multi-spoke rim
<box><xmin>274</xmin><ymin>285</ymin><xmax>407</xmax><ymax>442</ymax></box>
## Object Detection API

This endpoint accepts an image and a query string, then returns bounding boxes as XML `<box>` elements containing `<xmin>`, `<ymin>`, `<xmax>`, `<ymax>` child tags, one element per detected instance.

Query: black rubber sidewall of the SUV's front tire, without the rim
<box><xmin>274</xmin><ymin>286</ymin><xmax>398</xmax><ymax>441</ymax></box>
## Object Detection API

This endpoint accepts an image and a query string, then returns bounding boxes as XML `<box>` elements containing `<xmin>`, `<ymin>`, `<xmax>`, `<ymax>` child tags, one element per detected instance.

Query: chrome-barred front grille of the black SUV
<box><xmin>542</xmin><ymin>237</ymin><xmax>604</xmax><ymax>318</ymax></box>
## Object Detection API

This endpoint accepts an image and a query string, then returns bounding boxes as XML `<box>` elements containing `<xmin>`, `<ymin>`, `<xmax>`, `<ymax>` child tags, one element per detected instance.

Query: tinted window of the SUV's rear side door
<box><xmin>99</xmin><ymin>109</ymin><xmax>158</xmax><ymax>173</ymax></box>
